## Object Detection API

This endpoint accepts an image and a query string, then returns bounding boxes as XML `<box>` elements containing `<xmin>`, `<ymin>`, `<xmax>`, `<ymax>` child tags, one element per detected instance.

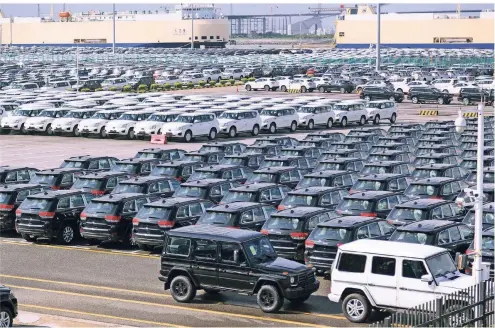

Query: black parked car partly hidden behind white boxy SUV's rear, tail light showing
<box><xmin>304</xmin><ymin>216</ymin><xmax>395</xmax><ymax>275</ymax></box>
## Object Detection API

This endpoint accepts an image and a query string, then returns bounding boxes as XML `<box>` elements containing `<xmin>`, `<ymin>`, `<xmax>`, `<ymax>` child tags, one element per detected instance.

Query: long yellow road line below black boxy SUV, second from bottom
<box><xmin>9</xmin><ymin>285</ymin><xmax>328</xmax><ymax>328</ymax></box>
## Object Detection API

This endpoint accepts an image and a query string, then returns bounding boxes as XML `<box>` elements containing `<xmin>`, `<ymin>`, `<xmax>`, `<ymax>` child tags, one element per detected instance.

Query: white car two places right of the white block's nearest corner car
<box><xmin>260</xmin><ymin>106</ymin><xmax>299</xmax><ymax>134</ymax></box>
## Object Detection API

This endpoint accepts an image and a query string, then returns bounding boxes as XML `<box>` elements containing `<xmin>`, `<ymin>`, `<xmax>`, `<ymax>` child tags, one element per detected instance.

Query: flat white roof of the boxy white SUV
<box><xmin>339</xmin><ymin>239</ymin><xmax>447</xmax><ymax>259</ymax></box>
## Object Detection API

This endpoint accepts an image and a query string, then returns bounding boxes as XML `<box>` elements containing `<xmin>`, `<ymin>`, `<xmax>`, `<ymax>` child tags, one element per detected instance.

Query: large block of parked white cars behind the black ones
<box><xmin>0</xmin><ymin>92</ymin><xmax>398</xmax><ymax>142</ymax></box>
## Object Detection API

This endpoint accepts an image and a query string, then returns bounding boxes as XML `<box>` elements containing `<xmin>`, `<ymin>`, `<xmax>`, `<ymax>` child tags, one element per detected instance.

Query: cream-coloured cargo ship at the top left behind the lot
<box><xmin>0</xmin><ymin>4</ymin><xmax>230</xmax><ymax>48</ymax></box>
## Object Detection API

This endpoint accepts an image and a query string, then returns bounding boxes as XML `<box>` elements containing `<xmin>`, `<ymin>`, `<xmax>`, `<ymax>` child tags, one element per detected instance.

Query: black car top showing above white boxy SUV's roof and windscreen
<box><xmin>390</xmin><ymin>220</ymin><xmax>474</xmax><ymax>258</ymax></box>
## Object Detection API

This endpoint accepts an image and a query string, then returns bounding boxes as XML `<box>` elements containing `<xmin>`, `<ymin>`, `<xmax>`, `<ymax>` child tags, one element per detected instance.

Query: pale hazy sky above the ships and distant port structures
<box><xmin>0</xmin><ymin>3</ymin><xmax>494</xmax><ymax>28</ymax></box>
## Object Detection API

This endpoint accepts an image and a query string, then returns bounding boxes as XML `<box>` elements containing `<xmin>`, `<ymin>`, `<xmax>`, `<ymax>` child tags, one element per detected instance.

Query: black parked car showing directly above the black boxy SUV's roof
<box><xmin>196</xmin><ymin>202</ymin><xmax>277</xmax><ymax>231</ymax></box>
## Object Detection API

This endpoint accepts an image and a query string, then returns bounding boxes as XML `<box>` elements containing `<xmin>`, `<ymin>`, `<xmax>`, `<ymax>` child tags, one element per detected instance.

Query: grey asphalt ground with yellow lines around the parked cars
<box><xmin>0</xmin><ymin>87</ymin><xmax>488</xmax><ymax>327</ymax></box>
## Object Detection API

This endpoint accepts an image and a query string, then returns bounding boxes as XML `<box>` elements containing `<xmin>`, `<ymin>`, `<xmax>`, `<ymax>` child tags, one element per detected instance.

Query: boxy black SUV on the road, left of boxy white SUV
<box><xmin>159</xmin><ymin>226</ymin><xmax>320</xmax><ymax>313</ymax></box>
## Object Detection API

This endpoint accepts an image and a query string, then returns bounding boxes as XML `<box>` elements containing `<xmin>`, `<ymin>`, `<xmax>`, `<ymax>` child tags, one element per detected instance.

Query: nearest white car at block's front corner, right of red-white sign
<box><xmin>162</xmin><ymin>112</ymin><xmax>220</xmax><ymax>142</ymax></box>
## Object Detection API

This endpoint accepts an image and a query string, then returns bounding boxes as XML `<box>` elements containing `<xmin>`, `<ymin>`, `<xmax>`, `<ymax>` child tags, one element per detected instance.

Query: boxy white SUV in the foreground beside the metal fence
<box><xmin>328</xmin><ymin>239</ymin><xmax>475</xmax><ymax>323</ymax></box>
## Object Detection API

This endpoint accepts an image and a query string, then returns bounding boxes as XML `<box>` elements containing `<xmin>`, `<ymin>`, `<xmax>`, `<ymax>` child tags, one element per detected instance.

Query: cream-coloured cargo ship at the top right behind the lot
<box><xmin>335</xmin><ymin>5</ymin><xmax>495</xmax><ymax>49</ymax></box>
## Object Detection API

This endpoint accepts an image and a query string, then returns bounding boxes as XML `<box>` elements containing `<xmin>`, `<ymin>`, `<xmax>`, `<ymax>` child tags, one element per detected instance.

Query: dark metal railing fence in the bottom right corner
<box><xmin>370</xmin><ymin>281</ymin><xmax>495</xmax><ymax>327</ymax></box>
